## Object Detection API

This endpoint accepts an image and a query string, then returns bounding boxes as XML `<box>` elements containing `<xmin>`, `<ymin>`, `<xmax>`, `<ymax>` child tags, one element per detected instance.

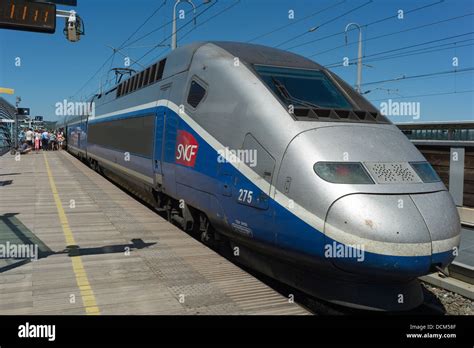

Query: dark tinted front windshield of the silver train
<box><xmin>255</xmin><ymin>65</ymin><xmax>353</xmax><ymax>109</ymax></box>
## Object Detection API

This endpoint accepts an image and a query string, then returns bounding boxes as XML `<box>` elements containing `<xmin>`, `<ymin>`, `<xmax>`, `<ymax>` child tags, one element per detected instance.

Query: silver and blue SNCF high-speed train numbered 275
<box><xmin>63</xmin><ymin>42</ymin><xmax>460</xmax><ymax>310</ymax></box>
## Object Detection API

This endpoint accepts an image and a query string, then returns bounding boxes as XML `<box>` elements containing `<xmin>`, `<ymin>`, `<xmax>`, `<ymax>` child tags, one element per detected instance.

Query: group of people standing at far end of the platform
<box><xmin>19</xmin><ymin>128</ymin><xmax>65</xmax><ymax>154</ymax></box>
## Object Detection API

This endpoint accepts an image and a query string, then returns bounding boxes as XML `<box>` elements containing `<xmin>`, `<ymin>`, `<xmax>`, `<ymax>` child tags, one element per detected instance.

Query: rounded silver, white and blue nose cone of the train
<box><xmin>324</xmin><ymin>191</ymin><xmax>460</xmax><ymax>278</ymax></box>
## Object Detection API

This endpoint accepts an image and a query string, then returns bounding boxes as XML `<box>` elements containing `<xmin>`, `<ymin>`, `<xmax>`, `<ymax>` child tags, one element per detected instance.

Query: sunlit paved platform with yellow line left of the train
<box><xmin>0</xmin><ymin>151</ymin><xmax>308</xmax><ymax>315</ymax></box>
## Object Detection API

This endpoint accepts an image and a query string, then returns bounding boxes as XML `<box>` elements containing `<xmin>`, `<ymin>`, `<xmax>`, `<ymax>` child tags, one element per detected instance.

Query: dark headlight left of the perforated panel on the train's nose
<box><xmin>313</xmin><ymin>162</ymin><xmax>374</xmax><ymax>184</ymax></box>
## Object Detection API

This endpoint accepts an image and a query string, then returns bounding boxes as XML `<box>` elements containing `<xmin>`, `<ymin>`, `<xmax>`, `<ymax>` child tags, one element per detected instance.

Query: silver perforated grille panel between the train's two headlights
<box><xmin>365</xmin><ymin>162</ymin><xmax>421</xmax><ymax>184</ymax></box>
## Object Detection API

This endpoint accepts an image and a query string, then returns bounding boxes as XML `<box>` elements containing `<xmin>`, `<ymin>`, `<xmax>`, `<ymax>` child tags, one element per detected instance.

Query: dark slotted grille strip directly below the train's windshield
<box><xmin>293</xmin><ymin>108</ymin><xmax>390</xmax><ymax>123</ymax></box>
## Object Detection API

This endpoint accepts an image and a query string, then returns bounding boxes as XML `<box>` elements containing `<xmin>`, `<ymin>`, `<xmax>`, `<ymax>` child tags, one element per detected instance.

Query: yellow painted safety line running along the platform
<box><xmin>43</xmin><ymin>153</ymin><xmax>100</xmax><ymax>315</ymax></box>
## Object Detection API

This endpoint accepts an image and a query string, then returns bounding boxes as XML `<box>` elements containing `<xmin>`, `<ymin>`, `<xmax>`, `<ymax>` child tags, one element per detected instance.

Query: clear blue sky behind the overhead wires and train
<box><xmin>0</xmin><ymin>0</ymin><xmax>474</xmax><ymax>122</ymax></box>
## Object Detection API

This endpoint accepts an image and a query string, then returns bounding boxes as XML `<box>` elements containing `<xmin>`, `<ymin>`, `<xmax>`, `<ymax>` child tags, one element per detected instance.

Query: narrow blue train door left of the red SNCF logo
<box><xmin>153</xmin><ymin>84</ymin><xmax>171</xmax><ymax>187</ymax></box>
